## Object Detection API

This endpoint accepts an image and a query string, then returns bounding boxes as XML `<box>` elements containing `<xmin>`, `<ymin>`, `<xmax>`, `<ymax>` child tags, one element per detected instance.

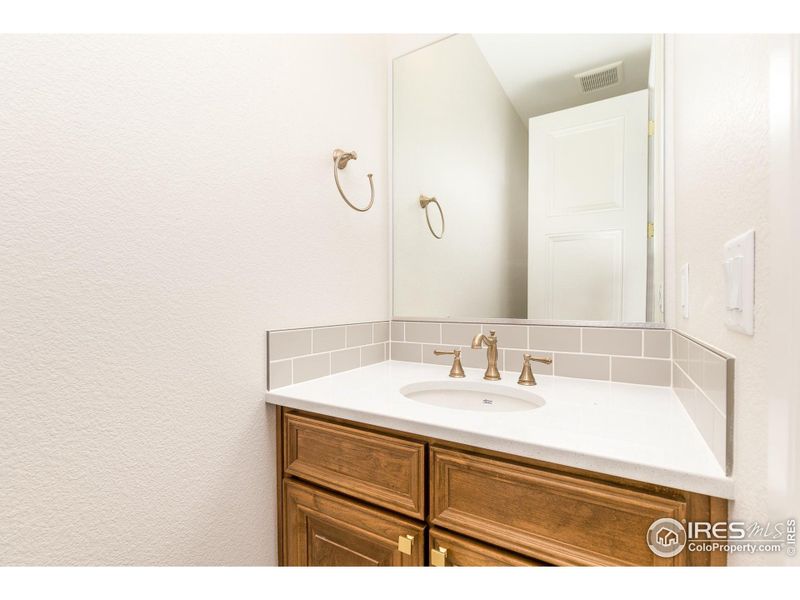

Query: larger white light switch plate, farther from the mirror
<box><xmin>722</xmin><ymin>229</ymin><xmax>756</xmax><ymax>335</ymax></box>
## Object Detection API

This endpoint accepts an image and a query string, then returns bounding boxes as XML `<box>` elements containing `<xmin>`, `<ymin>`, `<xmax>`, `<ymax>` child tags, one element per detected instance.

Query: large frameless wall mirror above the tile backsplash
<box><xmin>392</xmin><ymin>34</ymin><xmax>664</xmax><ymax>324</ymax></box>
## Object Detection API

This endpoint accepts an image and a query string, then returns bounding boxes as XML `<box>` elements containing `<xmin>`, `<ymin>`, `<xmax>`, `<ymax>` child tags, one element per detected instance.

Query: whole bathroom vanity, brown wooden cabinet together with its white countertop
<box><xmin>267</xmin><ymin>361</ymin><xmax>732</xmax><ymax>566</ymax></box>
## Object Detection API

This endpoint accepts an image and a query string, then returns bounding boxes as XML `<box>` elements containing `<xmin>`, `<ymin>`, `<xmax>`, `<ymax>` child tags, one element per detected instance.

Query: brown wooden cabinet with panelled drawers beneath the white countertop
<box><xmin>278</xmin><ymin>409</ymin><xmax>727</xmax><ymax>566</ymax></box>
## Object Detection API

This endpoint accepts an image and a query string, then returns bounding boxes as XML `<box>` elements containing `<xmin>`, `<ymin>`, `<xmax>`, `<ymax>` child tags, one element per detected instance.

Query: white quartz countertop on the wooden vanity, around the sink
<box><xmin>266</xmin><ymin>361</ymin><xmax>733</xmax><ymax>498</ymax></box>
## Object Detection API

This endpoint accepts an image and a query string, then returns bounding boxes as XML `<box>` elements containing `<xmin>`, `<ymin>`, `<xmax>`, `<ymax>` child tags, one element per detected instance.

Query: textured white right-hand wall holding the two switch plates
<box><xmin>673</xmin><ymin>35</ymin><xmax>772</xmax><ymax>564</ymax></box>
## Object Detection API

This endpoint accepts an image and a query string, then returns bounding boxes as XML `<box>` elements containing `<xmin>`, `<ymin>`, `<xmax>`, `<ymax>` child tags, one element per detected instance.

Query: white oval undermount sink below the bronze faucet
<box><xmin>400</xmin><ymin>381</ymin><xmax>545</xmax><ymax>412</ymax></box>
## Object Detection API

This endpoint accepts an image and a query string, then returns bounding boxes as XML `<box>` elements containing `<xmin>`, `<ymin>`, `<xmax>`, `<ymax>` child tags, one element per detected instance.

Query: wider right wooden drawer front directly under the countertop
<box><xmin>430</xmin><ymin>446</ymin><xmax>686</xmax><ymax>565</ymax></box>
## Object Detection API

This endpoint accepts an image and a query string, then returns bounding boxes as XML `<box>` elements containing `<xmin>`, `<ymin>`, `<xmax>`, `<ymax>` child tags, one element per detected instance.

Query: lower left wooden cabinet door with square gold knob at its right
<box><xmin>283</xmin><ymin>480</ymin><xmax>425</xmax><ymax>567</ymax></box>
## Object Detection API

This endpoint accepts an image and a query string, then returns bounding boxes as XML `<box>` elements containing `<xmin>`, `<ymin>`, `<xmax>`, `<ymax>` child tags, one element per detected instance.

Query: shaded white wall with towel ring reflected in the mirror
<box><xmin>393</xmin><ymin>35</ymin><xmax>528</xmax><ymax>318</ymax></box>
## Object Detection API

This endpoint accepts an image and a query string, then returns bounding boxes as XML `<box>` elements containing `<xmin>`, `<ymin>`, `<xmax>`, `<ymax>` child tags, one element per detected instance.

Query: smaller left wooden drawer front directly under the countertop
<box><xmin>283</xmin><ymin>413</ymin><xmax>425</xmax><ymax>519</ymax></box>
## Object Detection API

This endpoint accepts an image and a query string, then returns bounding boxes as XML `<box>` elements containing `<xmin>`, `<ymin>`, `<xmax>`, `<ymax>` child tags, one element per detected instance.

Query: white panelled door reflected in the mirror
<box><xmin>528</xmin><ymin>90</ymin><xmax>648</xmax><ymax>322</ymax></box>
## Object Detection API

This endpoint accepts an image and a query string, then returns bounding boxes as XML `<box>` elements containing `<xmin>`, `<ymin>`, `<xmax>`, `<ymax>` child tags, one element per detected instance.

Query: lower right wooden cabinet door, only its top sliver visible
<box><xmin>428</xmin><ymin>529</ymin><xmax>543</xmax><ymax>567</ymax></box>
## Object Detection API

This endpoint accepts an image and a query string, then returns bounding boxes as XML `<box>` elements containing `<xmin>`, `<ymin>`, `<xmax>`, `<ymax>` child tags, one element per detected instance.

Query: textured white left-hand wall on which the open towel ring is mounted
<box><xmin>0</xmin><ymin>36</ymin><xmax>389</xmax><ymax>564</ymax></box>
